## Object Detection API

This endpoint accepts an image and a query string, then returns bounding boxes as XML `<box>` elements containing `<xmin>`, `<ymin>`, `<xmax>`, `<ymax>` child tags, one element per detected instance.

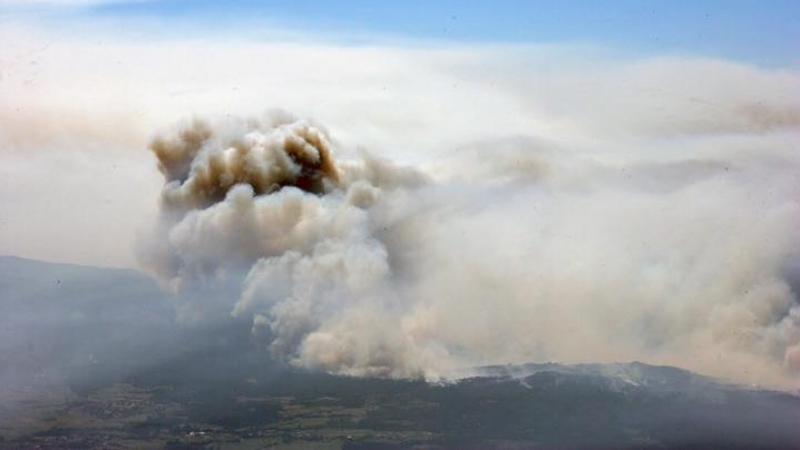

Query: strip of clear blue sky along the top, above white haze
<box><xmin>0</xmin><ymin>0</ymin><xmax>800</xmax><ymax>66</ymax></box>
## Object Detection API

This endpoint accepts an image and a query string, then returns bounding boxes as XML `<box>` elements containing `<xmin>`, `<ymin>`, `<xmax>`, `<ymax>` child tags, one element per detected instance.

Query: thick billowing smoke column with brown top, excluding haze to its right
<box><xmin>143</xmin><ymin>114</ymin><xmax>434</xmax><ymax>376</ymax></box>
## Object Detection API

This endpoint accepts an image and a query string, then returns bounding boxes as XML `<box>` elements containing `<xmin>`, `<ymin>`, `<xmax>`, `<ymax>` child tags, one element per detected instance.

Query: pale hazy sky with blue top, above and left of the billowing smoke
<box><xmin>0</xmin><ymin>0</ymin><xmax>800</xmax><ymax>266</ymax></box>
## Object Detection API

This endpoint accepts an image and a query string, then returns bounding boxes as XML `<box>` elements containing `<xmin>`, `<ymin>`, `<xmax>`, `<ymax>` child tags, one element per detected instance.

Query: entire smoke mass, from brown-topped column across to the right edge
<box><xmin>141</xmin><ymin>110</ymin><xmax>800</xmax><ymax>385</ymax></box>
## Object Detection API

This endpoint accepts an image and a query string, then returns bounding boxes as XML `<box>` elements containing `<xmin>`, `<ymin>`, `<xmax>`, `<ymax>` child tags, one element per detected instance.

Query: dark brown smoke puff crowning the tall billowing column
<box><xmin>150</xmin><ymin>120</ymin><xmax>339</xmax><ymax>209</ymax></box>
